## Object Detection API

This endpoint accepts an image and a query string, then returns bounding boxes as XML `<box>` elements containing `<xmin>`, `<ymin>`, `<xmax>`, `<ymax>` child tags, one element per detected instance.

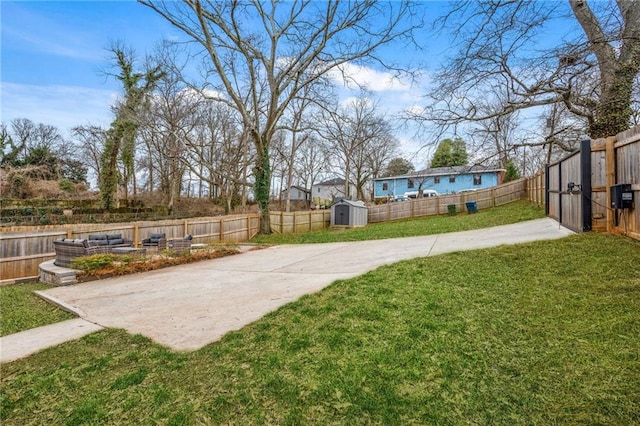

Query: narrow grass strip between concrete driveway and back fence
<box><xmin>251</xmin><ymin>201</ymin><xmax>544</xmax><ymax>244</ymax></box>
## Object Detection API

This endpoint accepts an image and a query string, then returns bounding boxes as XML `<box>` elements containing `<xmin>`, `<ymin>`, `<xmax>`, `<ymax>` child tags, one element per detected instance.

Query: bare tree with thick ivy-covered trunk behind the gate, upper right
<box><xmin>416</xmin><ymin>0</ymin><xmax>640</xmax><ymax>142</ymax></box>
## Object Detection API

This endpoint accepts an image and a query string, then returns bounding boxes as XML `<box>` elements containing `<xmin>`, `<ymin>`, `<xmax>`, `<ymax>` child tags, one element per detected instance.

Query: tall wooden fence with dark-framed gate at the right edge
<box><xmin>526</xmin><ymin>126</ymin><xmax>640</xmax><ymax>240</ymax></box>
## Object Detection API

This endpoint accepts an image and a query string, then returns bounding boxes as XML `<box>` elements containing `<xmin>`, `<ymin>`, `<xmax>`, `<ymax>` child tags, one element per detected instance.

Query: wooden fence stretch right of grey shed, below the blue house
<box><xmin>369</xmin><ymin>179</ymin><xmax>526</xmax><ymax>223</ymax></box>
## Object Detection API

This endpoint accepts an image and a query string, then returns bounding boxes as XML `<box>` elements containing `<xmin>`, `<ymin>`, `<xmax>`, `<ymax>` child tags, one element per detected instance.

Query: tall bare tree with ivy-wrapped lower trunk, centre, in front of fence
<box><xmin>139</xmin><ymin>0</ymin><xmax>416</xmax><ymax>234</ymax></box>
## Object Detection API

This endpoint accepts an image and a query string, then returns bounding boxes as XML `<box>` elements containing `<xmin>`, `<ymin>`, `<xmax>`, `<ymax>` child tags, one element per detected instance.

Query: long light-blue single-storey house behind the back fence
<box><xmin>373</xmin><ymin>165</ymin><xmax>505</xmax><ymax>199</ymax></box>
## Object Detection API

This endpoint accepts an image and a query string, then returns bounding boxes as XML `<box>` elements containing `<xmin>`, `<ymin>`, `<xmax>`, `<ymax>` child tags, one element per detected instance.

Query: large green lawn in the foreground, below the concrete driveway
<box><xmin>0</xmin><ymin>234</ymin><xmax>640</xmax><ymax>425</ymax></box>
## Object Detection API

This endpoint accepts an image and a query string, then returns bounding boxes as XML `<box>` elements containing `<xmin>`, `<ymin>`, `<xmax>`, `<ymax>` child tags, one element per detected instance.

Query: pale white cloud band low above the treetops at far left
<box><xmin>0</xmin><ymin>82</ymin><xmax>118</xmax><ymax>131</ymax></box>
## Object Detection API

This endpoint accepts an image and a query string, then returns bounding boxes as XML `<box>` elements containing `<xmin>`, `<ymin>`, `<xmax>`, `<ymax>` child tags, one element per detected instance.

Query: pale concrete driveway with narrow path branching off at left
<box><xmin>0</xmin><ymin>218</ymin><xmax>572</xmax><ymax>362</ymax></box>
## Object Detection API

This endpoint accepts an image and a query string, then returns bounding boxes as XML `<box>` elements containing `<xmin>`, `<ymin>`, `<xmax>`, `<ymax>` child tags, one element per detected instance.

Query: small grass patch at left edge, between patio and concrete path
<box><xmin>0</xmin><ymin>283</ymin><xmax>74</xmax><ymax>336</ymax></box>
